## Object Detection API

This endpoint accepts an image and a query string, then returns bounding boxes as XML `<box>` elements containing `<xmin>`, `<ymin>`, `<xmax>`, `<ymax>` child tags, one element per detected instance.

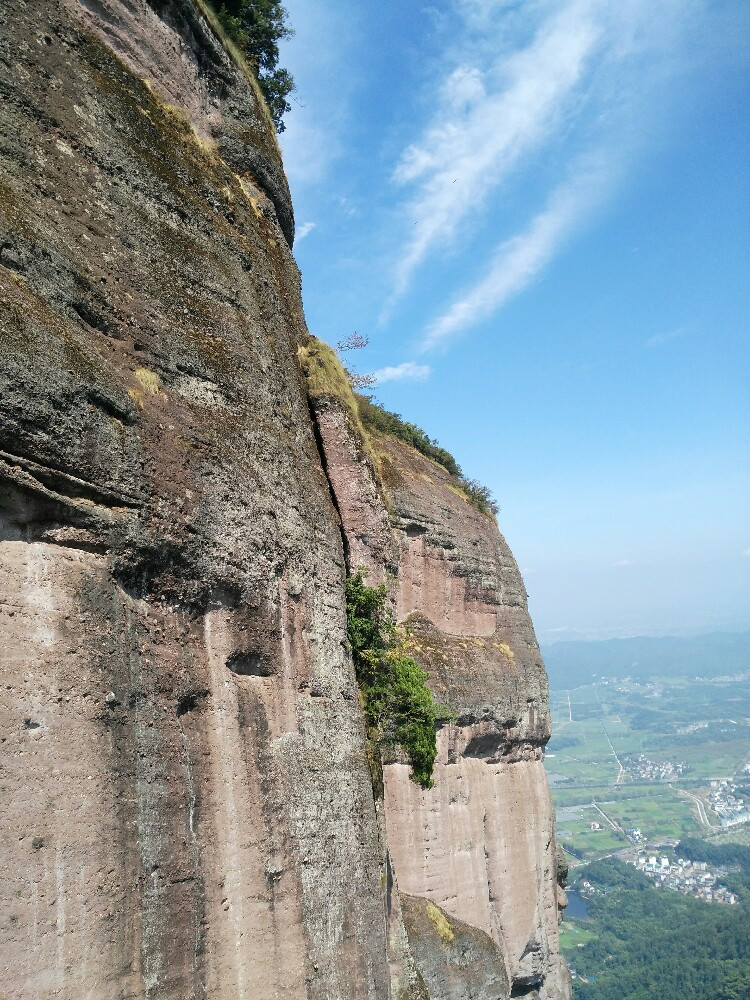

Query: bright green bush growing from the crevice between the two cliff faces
<box><xmin>346</xmin><ymin>570</ymin><xmax>449</xmax><ymax>788</ymax></box>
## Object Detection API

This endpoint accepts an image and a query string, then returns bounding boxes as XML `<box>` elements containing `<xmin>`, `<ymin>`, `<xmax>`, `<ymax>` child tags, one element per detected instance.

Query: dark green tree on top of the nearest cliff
<box><xmin>212</xmin><ymin>0</ymin><xmax>294</xmax><ymax>132</ymax></box>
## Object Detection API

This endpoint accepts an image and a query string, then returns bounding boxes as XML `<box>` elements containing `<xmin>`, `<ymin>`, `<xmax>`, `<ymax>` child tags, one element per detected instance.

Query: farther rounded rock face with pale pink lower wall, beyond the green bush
<box><xmin>378</xmin><ymin>439</ymin><xmax>566</xmax><ymax>998</ymax></box>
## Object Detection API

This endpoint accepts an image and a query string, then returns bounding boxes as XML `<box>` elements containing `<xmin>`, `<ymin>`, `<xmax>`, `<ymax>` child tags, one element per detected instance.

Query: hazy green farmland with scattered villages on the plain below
<box><xmin>546</xmin><ymin>664</ymin><xmax>750</xmax><ymax>865</ymax></box>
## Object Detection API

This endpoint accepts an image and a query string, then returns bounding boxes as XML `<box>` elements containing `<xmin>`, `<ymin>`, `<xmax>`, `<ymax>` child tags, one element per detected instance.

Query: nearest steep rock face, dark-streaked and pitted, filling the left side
<box><xmin>0</xmin><ymin>0</ymin><xmax>388</xmax><ymax>1000</ymax></box>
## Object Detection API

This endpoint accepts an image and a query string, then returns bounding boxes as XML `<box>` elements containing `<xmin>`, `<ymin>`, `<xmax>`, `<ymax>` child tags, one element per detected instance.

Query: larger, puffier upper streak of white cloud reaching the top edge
<box><xmin>393</xmin><ymin>0</ymin><xmax>602</xmax><ymax>297</ymax></box>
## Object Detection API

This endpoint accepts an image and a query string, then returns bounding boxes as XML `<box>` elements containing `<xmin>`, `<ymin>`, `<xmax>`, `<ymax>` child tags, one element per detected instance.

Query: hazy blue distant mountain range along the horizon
<box><xmin>542</xmin><ymin>632</ymin><xmax>750</xmax><ymax>690</ymax></box>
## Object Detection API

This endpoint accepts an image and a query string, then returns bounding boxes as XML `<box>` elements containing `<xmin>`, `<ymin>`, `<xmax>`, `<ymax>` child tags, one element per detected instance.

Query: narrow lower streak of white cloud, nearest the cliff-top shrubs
<box><xmin>421</xmin><ymin>158</ymin><xmax>613</xmax><ymax>351</ymax></box>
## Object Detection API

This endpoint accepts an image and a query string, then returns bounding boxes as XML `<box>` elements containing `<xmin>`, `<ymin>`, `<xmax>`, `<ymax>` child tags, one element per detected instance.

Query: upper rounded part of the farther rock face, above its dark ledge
<box><xmin>377</xmin><ymin>437</ymin><xmax>550</xmax><ymax>759</ymax></box>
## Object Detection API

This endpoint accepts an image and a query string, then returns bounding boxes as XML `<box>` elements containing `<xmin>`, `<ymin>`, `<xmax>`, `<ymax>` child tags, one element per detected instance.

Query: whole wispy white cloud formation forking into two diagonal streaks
<box><xmin>385</xmin><ymin>0</ymin><xmax>705</xmax><ymax>338</ymax></box>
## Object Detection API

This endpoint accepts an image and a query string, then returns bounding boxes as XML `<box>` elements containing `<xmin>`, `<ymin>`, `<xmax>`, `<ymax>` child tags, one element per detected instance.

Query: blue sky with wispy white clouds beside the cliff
<box><xmin>282</xmin><ymin>0</ymin><xmax>750</xmax><ymax>641</ymax></box>
